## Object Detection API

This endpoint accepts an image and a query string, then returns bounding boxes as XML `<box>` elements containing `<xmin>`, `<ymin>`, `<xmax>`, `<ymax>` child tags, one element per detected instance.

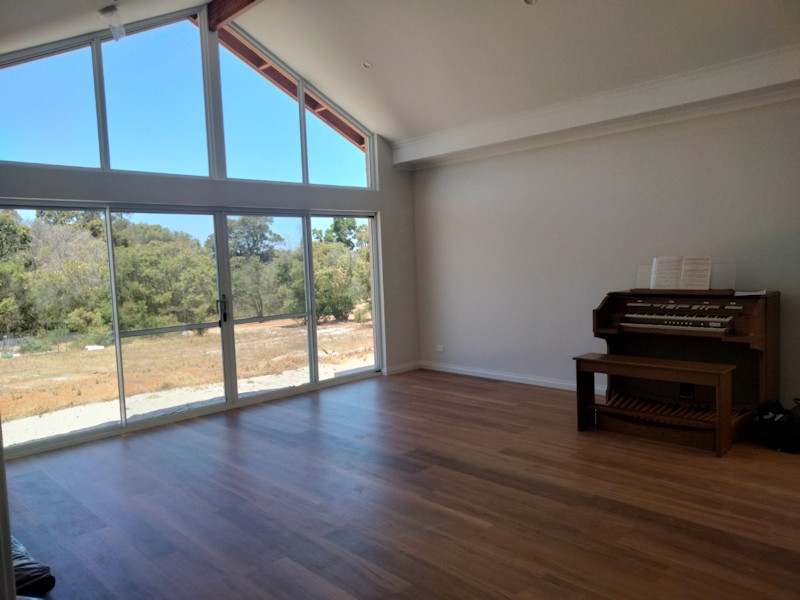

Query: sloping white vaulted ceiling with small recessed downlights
<box><xmin>0</xmin><ymin>0</ymin><xmax>800</xmax><ymax>142</ymax></box>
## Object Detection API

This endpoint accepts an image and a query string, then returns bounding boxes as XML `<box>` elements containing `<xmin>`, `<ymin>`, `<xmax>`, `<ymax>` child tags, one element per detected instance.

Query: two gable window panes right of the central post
<box><xmin>218</xmin><ymin>27</ymin><xmax>367</xmax><ymax>187</ymax></box>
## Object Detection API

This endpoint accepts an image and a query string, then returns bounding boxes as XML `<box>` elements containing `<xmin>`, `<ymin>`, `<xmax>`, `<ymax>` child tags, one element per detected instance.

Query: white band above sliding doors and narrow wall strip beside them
<box><xmin>0</xmin><ymin>139</ymin><xmax>419</xmax><ymax>370</ymax></box>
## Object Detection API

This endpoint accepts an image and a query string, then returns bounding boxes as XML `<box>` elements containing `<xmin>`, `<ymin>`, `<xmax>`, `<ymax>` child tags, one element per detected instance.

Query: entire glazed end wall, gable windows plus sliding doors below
<box><xmin>0</xmin><ymin>9</ymin><xmax>380</xmax><ymax>445</ymax></box>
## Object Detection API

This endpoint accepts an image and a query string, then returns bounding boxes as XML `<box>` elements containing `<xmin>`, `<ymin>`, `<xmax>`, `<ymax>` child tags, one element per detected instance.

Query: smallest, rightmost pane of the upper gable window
<box><xmin>306</xmin><ymin>92</ymin><xmax>367</xmax><ymax>187</ymax></box>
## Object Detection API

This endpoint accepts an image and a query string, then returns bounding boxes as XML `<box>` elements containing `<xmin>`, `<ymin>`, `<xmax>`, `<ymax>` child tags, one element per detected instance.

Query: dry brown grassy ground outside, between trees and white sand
<box><xmin>0</xmin><ymin>319</ymin><xmax>374</xmax><ymax>422</ymax></box>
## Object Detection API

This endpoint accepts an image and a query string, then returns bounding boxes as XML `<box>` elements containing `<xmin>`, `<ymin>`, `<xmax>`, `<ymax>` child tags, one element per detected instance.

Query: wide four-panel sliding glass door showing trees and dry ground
<box><xmin>0</xmin><ymin>207</ymin><xmax>379</xmax><ymax>445</ymax></box>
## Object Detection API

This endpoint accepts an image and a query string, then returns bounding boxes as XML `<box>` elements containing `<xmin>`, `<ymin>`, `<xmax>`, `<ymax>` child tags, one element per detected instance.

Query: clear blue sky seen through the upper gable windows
<box><xmin>0</xmin><ymin>21</ymin><xmax>367</xmax><ymax>187</ymax></box>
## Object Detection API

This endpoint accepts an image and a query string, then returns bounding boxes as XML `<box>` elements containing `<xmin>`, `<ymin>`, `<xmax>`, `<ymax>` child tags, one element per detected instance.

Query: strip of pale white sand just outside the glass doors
<box><xmin>3</xmin><ymin>358</ymin><xmax>372</xmax><ymax>446</ymax></box>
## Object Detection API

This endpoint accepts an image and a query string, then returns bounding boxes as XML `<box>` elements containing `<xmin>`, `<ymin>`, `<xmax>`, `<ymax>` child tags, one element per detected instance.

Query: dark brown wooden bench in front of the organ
<box><xmin>575</xmin><ymin>353</ymin><xmax>736</xmax><ymax>456</ymax></box>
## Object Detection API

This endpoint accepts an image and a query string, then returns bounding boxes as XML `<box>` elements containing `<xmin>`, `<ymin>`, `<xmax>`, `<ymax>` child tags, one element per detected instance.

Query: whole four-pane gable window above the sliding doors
<box><xmin>0</xmin><ymin>9</ymin><xmax>370</xmax><ymax>187</ymax></box>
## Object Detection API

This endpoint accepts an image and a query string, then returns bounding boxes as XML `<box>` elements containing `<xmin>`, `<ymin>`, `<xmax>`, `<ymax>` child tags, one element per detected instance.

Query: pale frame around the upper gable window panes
<box><xmin>0</xmin><ymin>5</ymin><xmax>378</xmax><ymax>190</ymax></box>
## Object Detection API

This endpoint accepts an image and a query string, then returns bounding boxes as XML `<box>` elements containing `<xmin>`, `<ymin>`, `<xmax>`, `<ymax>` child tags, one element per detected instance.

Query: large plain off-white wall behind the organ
<box><xmin>413</xmin><ymin>101</ymin><xmax>800</xmax><ymax>402</ymax></box>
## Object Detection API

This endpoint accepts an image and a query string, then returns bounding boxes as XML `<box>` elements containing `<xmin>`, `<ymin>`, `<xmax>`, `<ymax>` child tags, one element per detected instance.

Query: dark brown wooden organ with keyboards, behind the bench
<box><xmin>578</xmin><ymin>290</ymin><xmax>780</xmax><ymax>455</ymax></box>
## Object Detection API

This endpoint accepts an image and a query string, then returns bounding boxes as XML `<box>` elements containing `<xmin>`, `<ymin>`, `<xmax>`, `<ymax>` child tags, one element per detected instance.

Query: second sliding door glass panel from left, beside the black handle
<box><xmin>111</xmin><ymin>212</ymin><xmax>225</xmax><ymax>421</ymax></box>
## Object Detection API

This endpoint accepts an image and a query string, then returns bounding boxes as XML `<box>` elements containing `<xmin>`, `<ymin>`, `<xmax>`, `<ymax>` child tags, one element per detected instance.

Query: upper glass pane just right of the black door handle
<box><xmin>228</xmin><ymin>216</ymin><xmax>306</xmax><ymax>319</ymax></box>
